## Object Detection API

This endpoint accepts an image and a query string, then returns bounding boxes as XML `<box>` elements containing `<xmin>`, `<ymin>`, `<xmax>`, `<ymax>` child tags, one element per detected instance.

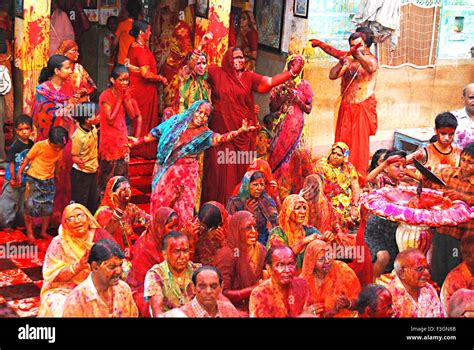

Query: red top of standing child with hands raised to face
<box><xmin>99</xmin><ymin>88</ymin><xmax>129</xmax><ymax>161</ymax></box>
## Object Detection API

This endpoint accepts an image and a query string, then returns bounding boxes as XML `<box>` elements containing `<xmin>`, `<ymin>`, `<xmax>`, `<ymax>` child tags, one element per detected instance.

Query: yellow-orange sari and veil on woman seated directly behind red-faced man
<box><xmin>267</xmin><ymin>194</ymin><xmax>322</xmax><ymax>270</ymax></box>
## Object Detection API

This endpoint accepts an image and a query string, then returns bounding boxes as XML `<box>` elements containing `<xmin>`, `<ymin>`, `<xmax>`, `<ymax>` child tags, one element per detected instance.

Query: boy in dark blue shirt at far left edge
<box><xmin>0</xmin><ymin>114</ymin><xmax>34</xmax><ymax>228</ymax></box>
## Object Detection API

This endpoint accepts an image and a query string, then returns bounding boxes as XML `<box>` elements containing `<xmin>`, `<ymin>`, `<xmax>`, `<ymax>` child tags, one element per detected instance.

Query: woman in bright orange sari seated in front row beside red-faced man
<box><xmin>301</xmin><ymin>240</ymin><xmax>360</xmax><ymax>317</ymax></box>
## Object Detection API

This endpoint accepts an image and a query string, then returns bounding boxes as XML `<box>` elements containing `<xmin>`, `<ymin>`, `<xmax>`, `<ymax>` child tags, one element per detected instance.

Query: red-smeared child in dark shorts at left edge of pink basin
<box><xmin>364</xmin><ymin>151</ymin><xmax>406</xmax><ymax>278</ymax></box>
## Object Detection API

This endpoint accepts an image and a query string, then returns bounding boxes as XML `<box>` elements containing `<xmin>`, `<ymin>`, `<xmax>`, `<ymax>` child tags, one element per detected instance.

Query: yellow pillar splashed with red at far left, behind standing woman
<box><xmin>14</xmin><ymin>0</ymin><xmax>50</xmax><ymax>115</ymax></box>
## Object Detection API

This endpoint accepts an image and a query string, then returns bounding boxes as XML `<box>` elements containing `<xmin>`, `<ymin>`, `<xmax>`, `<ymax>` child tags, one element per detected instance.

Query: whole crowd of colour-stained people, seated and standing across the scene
<box><xmin>0</xmin><ymin>6</ymin><xmax>474</xmax><ymax>318</ymax></box>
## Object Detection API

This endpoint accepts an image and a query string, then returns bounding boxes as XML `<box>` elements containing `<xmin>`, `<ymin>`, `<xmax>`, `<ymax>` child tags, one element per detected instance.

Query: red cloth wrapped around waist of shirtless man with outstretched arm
<box><xmin>336</xmin><ymin>95</ymin><xmax>377</xmax><ymax>178</ymax></box>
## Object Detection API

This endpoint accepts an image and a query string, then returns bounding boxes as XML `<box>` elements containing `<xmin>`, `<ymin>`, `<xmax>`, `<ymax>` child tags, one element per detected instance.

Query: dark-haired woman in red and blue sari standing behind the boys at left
<box><xmin>31</xmin><ymin>55</ymin><xmax>78</xmax><ymax>224</ymax></box>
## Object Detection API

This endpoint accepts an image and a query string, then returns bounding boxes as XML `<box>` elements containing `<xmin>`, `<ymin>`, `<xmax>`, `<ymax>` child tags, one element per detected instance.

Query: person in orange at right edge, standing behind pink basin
<box><xmin>431</xmin><ymin>142</ymin><xmax>474</xmax><ymax>286</ymax></box>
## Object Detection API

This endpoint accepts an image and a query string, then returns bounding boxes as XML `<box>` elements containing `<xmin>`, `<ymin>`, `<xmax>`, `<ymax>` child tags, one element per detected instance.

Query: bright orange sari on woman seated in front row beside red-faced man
<box><xmin>301</xmin><ymin>240</ymin><xmax>360</xmax><ymax>317</ymax></box>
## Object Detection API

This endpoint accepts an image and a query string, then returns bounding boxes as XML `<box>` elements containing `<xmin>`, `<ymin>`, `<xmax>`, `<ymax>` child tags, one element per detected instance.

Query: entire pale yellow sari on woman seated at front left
<box><xmin>38</xmin><ymin>203</ymin><xmax>107</xmax><ymax>317</ymax></box>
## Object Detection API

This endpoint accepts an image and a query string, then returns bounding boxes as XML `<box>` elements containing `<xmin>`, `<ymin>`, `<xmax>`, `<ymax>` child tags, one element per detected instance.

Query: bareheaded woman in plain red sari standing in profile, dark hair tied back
<box><xmin>128</xmin><ymin>20</ymin><xmax>167</xmax><ymax>158</ymax></box>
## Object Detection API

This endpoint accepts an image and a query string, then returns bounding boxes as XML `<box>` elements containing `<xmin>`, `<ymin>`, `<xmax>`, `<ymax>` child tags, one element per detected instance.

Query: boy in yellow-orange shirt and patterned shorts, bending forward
<box><xmin>17</xmin><ymin>126</ymin><xmax>68</xmax><ymax>243</ymax></box>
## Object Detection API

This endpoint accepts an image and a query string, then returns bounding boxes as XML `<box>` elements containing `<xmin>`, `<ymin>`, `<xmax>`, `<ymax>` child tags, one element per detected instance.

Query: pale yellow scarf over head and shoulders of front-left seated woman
<box><xmin>41</xmin><ymin>203</ymin><xmax>100</xmax><ymax>294</ymax></box>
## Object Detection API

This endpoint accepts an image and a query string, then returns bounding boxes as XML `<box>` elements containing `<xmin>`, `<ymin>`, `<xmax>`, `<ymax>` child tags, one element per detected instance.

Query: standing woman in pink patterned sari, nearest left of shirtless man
<box><xmin>269</xmin><ymin>55</ymin><xmax>313</xmax><ymax>194</ymax></box>
